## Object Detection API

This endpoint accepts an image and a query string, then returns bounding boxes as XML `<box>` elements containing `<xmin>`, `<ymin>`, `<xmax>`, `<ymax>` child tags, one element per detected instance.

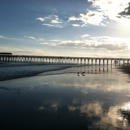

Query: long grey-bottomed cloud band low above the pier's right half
<box><xmin>48</xmin><ymin>34</ymin><xmax>130</xmax><ymax>51</ymax></box>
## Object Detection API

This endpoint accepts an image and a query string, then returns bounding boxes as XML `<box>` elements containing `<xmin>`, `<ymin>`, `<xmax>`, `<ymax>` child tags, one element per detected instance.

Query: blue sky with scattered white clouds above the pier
<box><xmin>0</xmin><ymin>0</ymin><xmax>130</xmax><ymax>57</ymax></box>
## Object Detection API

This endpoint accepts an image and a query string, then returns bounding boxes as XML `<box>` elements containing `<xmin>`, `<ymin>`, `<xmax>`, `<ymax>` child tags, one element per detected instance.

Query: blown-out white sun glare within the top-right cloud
<box><xmin>89</xmin><ymin>0</ymin><xmax>130</xmax><ymax>21</ymax></box>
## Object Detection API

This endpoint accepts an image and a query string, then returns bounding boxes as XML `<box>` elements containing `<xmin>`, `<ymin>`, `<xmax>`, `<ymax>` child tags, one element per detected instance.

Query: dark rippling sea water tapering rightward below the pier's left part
<box><xmin>0</xmin><ymin>63</ymin><xmax>84</xmax><ymax>81</ymax></box>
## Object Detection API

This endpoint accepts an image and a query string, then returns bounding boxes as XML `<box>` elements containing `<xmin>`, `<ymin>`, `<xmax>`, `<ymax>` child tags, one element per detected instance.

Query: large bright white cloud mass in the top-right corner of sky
<box><xmin>68</xmin><ymin>0</ymin><xmax>130</xmax><ymax>27</ymax></box>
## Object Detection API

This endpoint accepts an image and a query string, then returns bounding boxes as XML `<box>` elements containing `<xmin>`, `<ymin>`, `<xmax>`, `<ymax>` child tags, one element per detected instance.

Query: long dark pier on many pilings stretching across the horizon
<box><xmin>0</xmin><ymin>54</ymin><xmax>130</xmax><ymax>65</ymax></box>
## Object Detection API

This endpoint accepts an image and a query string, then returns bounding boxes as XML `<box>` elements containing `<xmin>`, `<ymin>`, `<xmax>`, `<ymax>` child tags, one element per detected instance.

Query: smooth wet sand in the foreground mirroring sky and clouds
<box><xmin>0</xmin><ymin>66</ymin><xmax>130</xmax><ymax>130</ymax></box>
